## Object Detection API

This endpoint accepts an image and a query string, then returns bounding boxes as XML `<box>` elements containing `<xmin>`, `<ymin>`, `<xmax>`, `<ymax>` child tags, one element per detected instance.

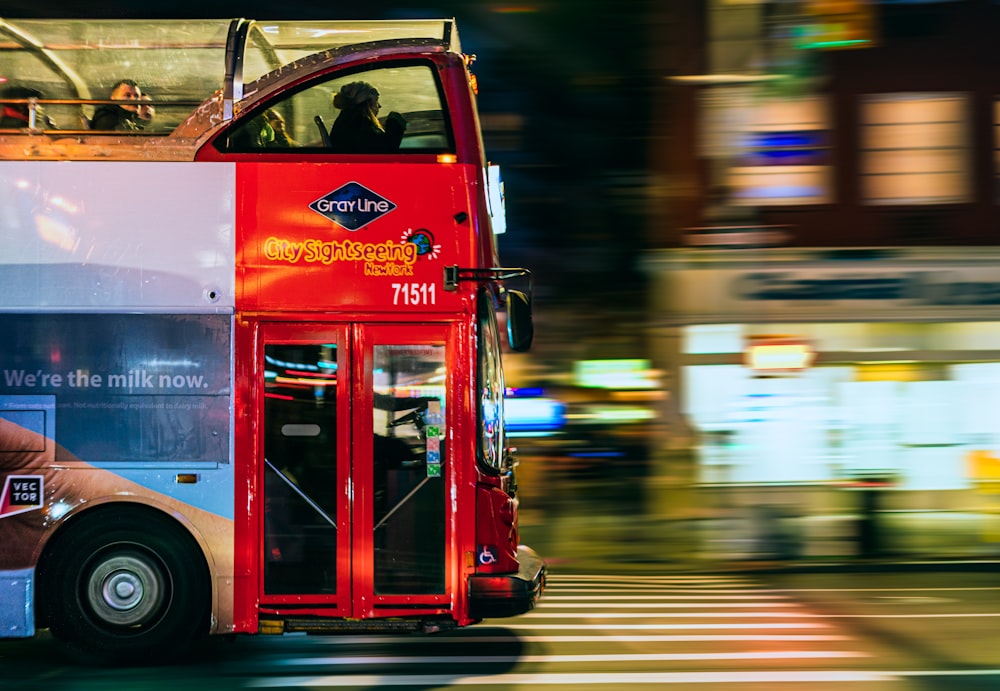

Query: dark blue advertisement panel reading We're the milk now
<box><xmin>0</xmin><ymin>314</ymin><xmax>232</xmax><ymax>465</ymax></box>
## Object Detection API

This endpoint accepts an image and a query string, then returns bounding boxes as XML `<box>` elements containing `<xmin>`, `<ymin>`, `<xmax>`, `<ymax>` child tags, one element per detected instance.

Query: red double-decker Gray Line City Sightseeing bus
<box><xmin>0</xmin><ymin>19</ymin><xmax>546</xmax><ymax>663</ymax></box>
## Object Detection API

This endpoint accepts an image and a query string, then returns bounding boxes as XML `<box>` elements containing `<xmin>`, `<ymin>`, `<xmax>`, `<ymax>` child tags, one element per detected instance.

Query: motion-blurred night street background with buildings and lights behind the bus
<box><xmin>7</xmin><ymin>0</ymin><xmax>1000</xmax><ymax>569</ymax></box>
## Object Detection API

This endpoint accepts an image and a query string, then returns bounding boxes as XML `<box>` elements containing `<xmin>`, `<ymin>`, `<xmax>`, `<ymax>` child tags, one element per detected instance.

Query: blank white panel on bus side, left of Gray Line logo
<box><xmin>0</xmin><ymin>161</ymin><xmax>235</xmax><ymax>312</ymax></box>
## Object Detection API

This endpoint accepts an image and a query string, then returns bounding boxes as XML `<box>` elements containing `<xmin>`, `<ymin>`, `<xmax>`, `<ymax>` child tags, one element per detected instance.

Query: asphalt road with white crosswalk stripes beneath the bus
<box><xmin>0</xmin><ymin>571</ymin><xmax>1000</xmax><ymax>691</ymax></box>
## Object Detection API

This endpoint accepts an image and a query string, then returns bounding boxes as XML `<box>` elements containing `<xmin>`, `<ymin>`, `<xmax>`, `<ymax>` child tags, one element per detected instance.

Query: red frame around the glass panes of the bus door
<box><xmin>236</xmin><ymin>320</ymin><xmax>475</xmax><ymax>631</ymax></box>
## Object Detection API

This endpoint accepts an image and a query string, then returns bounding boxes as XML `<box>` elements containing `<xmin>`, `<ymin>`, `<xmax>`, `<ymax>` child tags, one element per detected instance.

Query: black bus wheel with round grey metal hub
<box><xmin>39</xmin><ymin>506</ymin><xmax>211</xmax><ymax>665</ymax></box>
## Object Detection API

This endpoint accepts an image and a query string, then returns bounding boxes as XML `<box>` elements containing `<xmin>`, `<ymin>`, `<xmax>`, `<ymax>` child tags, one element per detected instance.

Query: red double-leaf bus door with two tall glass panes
<box><xmin>258</xmin><ymin>323</ymin><xmax>454</xmax><ymax>618</ymax></box>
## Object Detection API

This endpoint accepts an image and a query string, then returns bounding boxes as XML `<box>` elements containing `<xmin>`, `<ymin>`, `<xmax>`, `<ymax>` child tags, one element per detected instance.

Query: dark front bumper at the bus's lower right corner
<box><xmin>469</xmin><ymin>545</ymin><xmax>546</xmax><ymax>619</ymax></box>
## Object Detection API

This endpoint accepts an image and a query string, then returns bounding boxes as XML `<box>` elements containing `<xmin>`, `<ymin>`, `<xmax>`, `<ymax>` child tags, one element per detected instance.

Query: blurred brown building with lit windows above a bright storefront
<box><xmin>644</xmin><ymin>0</ymin><xmax>1000</xmax><ymax>555</ymax></box>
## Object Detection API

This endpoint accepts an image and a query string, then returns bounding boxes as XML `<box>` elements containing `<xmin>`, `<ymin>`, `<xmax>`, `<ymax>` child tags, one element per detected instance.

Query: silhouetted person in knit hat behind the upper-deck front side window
<box><xmin>330</xmin><ymin>82</ymin><xmax>406</xmax><ymax>154</ymax></box>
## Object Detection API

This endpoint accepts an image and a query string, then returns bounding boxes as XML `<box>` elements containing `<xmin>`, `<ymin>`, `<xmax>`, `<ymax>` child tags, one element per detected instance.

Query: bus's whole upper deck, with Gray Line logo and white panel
<box><xmin>0</xmin><ymin>19</ymin><xmax>526</xmax><ymax>314</ymax></box>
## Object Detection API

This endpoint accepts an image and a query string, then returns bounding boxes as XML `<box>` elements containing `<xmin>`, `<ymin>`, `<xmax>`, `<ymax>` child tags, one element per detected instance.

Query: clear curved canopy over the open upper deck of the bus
<box><xmin>0</xmin><ymin>19</ymin><xmax>461</xmax><ymax>137</ymax></box>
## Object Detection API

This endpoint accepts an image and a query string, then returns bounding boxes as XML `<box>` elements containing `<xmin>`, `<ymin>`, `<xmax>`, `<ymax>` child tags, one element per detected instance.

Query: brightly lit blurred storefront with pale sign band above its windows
<box><xmin>653</xmin><ymin>248</ymin><xmax>1000</xmax><ymax>491</ymax></box>
